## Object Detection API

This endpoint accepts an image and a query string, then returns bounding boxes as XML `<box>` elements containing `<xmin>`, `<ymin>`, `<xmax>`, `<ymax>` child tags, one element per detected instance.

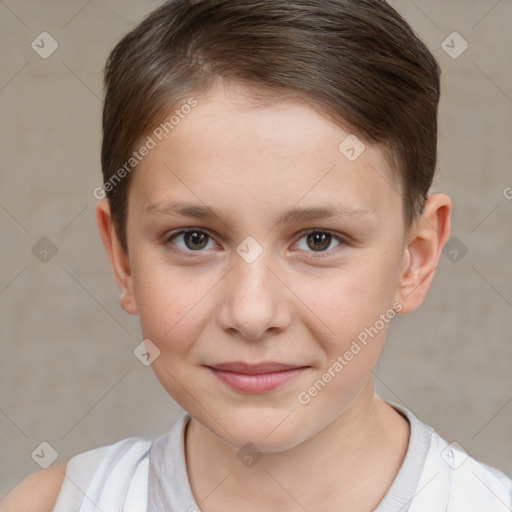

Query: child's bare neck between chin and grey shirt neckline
<box><xmin>185</xmin><ymin>382</ymin><xmax>409</xmax><ymax>512</ymax></box>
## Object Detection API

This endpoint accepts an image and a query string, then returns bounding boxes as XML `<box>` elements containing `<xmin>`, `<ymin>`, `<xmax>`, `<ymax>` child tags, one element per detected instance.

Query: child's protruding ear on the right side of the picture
<box><xmin>395</xmin><ymin>194</ymin><xmax>452</xmax><ymax>313</ymax></box>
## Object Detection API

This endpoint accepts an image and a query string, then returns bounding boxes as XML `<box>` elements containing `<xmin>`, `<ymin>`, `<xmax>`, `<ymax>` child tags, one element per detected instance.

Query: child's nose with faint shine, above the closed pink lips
<box><xmin>216</xmin><ymin>255</ymin><xmax>292</xmax><ymax>341</ymax></box>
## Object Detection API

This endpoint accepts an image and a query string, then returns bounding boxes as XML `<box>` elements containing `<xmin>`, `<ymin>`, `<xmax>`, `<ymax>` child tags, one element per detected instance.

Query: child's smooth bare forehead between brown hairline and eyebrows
<box><xmin>130</xmin><ymin>81</ymin><xmax>401</xmax><ymax>219</ymax></box>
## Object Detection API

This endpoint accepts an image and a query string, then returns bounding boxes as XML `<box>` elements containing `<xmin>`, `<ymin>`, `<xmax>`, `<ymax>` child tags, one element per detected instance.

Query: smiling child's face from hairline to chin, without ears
<box><xmin>120</xmin><ymin>82</ymin><xmax>405</xmax><ymax>451</ymax></box>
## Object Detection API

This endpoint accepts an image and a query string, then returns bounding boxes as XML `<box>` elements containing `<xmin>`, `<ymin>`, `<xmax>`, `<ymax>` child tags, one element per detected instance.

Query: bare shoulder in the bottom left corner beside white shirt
<box><xmin>0</xmin><ymin>463</ymin><xmax>67</xmax><ymax>512</ymax></box>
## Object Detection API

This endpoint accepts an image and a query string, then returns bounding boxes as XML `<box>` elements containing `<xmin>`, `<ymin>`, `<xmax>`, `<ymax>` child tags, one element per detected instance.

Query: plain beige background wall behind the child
<box><xmin>0</xmin><ymin>0</ymin><xmax>512</xmax><ymax>497</ymax></box>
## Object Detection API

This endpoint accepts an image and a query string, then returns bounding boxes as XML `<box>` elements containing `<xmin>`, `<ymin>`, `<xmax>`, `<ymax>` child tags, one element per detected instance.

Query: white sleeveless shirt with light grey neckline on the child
<box><xmin>53</xmin><ymin>402</ymin><xmax>512</xmax><ymax>512</ymax></box>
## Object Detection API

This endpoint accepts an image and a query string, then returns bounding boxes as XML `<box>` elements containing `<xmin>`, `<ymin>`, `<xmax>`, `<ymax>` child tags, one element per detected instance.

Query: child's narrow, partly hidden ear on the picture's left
<box><xmin>96</xmin><ymin>199</ymin><xmax>138</xmax><ymax>315</ymax></box>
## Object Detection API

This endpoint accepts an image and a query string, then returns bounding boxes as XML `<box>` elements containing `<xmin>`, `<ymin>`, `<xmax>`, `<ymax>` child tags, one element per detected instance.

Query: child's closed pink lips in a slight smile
<box><xmin>208</xmin><ymin>361</ymin><xmax>308</xmax><ymax>393</ymax></box>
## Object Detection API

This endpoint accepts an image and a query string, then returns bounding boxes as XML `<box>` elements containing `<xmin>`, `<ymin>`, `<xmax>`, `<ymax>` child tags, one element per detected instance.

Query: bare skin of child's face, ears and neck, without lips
<box><xmin>93</xmin><ymin>84</ymin><xmax>451</xmax><ymax>512</ymax></box>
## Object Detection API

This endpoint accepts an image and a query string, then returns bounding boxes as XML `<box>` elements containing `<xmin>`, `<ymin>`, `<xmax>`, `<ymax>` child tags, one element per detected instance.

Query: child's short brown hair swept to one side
<box><xmin>101</xmin><ymin>0</ymin><xmax>440</xmax><ymax>251</ymax></box>
